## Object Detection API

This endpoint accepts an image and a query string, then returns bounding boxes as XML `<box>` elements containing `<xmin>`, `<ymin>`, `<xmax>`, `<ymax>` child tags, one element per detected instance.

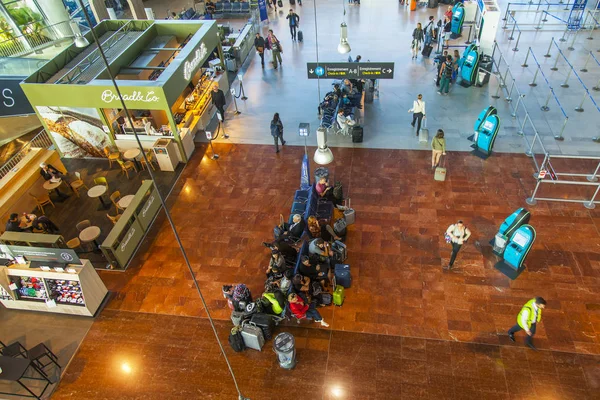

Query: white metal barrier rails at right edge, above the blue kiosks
<box><xmin>525</xmin><ymin>154</ymin><xmax>600</xmax><ymax>209</ymax></box>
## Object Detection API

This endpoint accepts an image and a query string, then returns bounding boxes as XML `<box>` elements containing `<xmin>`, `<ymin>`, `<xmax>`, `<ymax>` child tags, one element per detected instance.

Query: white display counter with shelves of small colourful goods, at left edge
<box><xmin>0</xmin><ymin>259</ymin><xmax>108</xmax><ymax>317</ymax></box>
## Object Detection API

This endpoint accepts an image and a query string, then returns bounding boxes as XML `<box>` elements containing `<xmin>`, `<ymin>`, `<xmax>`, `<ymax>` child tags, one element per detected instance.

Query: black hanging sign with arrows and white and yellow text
<box><xmin>306</xmin><ymin>62</ymin><xmax>394</xmax><ymax>79</ymax></box>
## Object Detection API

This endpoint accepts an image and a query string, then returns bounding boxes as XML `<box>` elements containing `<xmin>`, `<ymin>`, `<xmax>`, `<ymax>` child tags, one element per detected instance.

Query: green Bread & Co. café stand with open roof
<box><xmin>21</xmin><ymin>20</ymin><xmax>229</xmax><ymax>163</ymax></box>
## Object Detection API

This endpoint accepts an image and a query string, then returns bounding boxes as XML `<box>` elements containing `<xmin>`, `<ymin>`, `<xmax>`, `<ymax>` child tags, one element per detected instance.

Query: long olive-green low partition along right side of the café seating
<box><xmin>100</xmin><ymin>180</ymin><xmax>160</xmax><ymax>269</ymax></box>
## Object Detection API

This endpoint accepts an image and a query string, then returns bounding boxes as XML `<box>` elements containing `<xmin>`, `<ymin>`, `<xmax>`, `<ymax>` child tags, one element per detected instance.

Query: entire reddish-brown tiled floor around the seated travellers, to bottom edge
<box><xmin>48</xmin><ymin>144</ymin><xmax>600</xmax><ymax>399</ymax></box>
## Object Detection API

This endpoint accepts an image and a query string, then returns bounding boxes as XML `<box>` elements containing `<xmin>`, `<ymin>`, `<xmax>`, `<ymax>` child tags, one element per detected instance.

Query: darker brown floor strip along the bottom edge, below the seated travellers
<box><xmin>52</xmin><ymin>311</ymin><xmax>600</xmax><ymax>400</ymax></box>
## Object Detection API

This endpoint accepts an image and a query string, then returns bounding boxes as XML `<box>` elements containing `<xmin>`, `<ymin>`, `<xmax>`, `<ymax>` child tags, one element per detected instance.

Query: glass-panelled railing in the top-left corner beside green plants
<box><xmin>0</xmin><ymin>21</ymin><xmax>74</xmax><ymax>57</ymax></box>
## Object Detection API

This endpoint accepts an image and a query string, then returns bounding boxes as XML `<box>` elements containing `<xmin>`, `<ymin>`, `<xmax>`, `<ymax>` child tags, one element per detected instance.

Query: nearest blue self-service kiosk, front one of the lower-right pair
<box><xmin>495</xmin><ymin>224</ymin><xmax>536</xmax><ymax>280</ymax></box>
